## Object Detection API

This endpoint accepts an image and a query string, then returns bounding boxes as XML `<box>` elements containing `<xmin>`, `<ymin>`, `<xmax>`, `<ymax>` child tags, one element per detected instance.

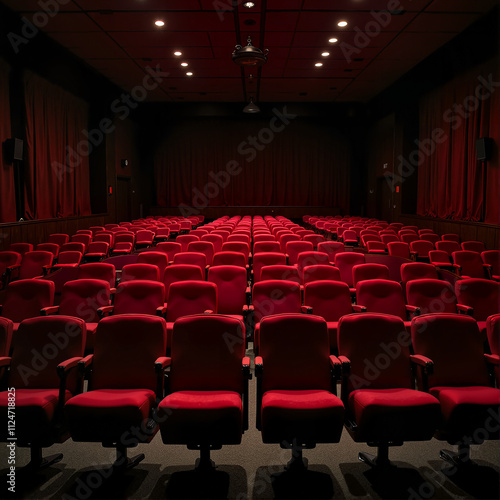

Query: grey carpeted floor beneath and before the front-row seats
<box><xmin>0</xmin><ymin>348</ymin><xmax>500</xmax><ymax>500</ymax></box>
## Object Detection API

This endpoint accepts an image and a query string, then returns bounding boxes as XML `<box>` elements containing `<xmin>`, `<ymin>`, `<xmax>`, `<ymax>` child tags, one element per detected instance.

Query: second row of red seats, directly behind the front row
<box><xmin>1</xmin><ymin>272</ymin><xmax>500</xmax><ymax>353</ymax></box>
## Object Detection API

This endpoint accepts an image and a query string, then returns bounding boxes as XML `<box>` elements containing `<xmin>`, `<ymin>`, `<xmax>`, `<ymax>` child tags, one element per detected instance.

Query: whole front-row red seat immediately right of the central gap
<box><xmin>255</xmin><ymin>314</ymin><xmax>344</xmax><ymax>471</ymax></box>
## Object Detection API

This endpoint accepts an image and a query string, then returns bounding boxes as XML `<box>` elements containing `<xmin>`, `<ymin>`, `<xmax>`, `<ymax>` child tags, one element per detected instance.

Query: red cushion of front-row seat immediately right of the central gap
<box><xmin>262</xmin><ymin>390</ymin><xmax>344</xmax><ymax>443</ymax></box>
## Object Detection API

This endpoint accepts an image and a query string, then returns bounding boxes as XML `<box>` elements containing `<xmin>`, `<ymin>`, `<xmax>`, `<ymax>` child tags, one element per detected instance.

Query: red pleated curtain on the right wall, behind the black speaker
<box><xmin>413</xmin><ymin>57</ymin><xmax>500</xmax><ymax>224</ymax></box>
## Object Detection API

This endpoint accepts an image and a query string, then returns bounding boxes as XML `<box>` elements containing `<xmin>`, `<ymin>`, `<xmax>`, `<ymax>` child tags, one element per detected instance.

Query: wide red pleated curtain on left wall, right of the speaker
<box><xmin>24</xmin><ymin>72</ymin><xmax>91</xmax><ymax>219</ymax></box>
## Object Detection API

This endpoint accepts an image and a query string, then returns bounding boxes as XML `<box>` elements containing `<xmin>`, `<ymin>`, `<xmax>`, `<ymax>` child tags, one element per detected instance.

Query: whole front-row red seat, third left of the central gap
<box><xmin>0</xmin><ymin>316</ymin><xmax>86</xmax><ymax>468</ymax></box>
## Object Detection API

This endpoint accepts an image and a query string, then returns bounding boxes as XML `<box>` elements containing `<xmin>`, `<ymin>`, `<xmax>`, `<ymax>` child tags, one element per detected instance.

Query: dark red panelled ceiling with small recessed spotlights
<box><xmin>1</xmin><ymin>0</ymin><xmax>498</xmax><ymax>102</ymax></box>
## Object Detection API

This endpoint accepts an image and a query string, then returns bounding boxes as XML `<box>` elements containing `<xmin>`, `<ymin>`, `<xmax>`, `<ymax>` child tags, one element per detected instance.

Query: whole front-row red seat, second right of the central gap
<box><xmin>338</xmin><ymin>313</ymin><xmax>440</xmax><ymax>468</ymax></box>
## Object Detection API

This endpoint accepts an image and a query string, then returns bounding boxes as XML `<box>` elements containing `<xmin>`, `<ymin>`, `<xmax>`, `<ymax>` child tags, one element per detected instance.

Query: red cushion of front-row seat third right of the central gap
<box><xmin>430</xmin><ymin>386</ymin><xmax>500</xmax><ymax>439</ymax></box>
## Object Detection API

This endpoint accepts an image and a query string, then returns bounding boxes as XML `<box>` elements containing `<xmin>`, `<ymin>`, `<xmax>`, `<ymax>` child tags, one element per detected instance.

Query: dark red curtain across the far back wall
<box><xmin>155</xmin><ymin>116</ymin><xmax>350</xmax><ymax>211</ymax></box>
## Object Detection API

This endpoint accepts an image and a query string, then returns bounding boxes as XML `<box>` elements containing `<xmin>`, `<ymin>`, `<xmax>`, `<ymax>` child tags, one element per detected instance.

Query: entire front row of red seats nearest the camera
<box><xmin>0</xmin><ymin>313</ymin><xmax>500</xmax><ymax>470</ymax></box>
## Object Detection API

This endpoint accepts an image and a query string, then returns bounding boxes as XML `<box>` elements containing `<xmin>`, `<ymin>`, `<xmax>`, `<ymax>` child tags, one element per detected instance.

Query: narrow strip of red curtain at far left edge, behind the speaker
<box><xmin>0</xmin><ymin>59</ymin><xmax>16</xmax><ymax>222</ymax></box>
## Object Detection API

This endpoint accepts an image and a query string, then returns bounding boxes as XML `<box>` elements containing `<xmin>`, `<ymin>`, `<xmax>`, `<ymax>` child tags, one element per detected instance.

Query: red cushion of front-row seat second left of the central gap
<box><xmin>65</xmin><ymin>389</ymin><xmax>155</xmax><ymax>442</ymax></box>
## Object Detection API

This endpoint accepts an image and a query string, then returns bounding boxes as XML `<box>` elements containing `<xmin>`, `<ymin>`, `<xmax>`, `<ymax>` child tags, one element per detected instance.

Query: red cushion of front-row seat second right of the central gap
<box><xmin>349</xmin><ymin>388</ymin><xmax>440</xmax><ymax>442</ymax></box>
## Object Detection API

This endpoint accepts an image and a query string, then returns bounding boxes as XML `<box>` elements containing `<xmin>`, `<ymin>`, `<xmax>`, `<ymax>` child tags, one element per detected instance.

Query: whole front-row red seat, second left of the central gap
<box><xmin>64</xmin><ymin>314</ymin><xmax>167</xmax><ymax>470</ymax></box>
